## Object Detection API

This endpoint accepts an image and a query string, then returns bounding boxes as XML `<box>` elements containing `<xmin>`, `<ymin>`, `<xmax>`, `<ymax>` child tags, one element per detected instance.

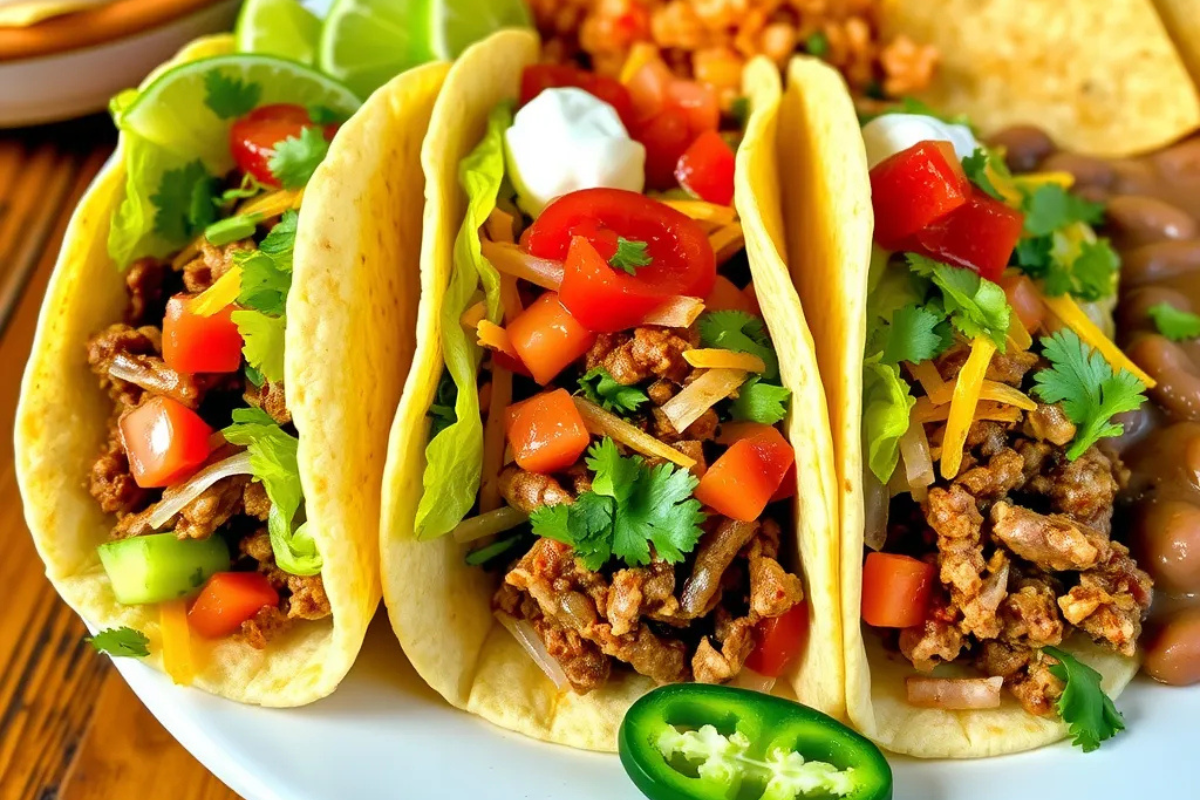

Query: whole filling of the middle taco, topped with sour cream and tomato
<box><xmin>415</xmin><ymin>59</ymin><xmax>808</xmax><ymax>693</ymax></box>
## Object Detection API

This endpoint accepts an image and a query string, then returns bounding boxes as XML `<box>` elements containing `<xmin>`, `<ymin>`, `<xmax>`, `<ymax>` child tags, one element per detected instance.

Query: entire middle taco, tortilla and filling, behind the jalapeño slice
<box><xmin>380</xmin><ymin>31</ymin><xmax>842</xmax><ymax>750</ymax></box>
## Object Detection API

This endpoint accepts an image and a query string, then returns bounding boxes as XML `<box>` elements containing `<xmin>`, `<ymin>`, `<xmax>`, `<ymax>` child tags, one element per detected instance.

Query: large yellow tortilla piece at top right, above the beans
<box><xmin>881</xmin><ymin>0</ymin><xmax>1200</xmax><ymax>156</ymax></box>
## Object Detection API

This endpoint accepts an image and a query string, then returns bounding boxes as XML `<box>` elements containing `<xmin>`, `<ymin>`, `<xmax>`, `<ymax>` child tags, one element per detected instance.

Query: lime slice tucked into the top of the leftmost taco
<box><xmin>116</xmin><ymin>53</ymin><xmax>359</xmax><ymax>175</ymax></box>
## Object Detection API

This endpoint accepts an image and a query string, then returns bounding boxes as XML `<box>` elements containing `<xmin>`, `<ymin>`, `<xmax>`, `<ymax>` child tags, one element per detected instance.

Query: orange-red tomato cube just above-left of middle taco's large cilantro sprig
<box><xmin>508</xmin><ymin>389</ymin><xmax>589</xmax><ymax>474</ymax></box>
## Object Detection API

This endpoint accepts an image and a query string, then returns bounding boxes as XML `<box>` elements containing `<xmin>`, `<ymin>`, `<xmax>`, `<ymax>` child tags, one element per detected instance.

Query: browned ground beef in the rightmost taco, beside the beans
<box><xmin>888</xmin><ymin>349</ymin><xmax>1151</xmax><ymax>714</ymax></box>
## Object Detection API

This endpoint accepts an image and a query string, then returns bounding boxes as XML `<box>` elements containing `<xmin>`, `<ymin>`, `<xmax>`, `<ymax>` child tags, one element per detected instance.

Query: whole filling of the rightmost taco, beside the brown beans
<box><xmin>862</xmin><ymin>114</ymin><xmax>1153</xmax><ymax>729</ymax></box>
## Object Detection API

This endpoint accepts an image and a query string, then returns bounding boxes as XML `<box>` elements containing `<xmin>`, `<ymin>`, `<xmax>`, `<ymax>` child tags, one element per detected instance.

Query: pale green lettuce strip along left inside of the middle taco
<box><xmin>415</xmin><ymin>103</ymin><xmax>512</xmax><ymax>540</ymax></box>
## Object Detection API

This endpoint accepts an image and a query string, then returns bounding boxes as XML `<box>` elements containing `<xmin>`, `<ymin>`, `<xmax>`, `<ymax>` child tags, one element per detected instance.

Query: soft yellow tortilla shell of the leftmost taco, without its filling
<box><xmin>16</xmin><ymin>36</ymin><xmax>446</xmax><ymax>706</ymax></box>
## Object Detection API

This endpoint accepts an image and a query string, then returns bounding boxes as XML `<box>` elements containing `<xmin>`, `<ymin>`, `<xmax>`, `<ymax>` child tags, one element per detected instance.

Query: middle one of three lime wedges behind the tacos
<box><xmin>317</xmin><ymin>0</ymin><xmax>434</xmax><ymax>97</ymax></box>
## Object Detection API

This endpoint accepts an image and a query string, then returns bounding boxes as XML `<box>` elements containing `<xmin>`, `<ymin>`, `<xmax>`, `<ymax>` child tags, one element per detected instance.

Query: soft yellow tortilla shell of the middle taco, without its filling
<box><xmin>380</xmin><ymin>31</ymin><xmax>844</xmax><ymax>751</ymax></box>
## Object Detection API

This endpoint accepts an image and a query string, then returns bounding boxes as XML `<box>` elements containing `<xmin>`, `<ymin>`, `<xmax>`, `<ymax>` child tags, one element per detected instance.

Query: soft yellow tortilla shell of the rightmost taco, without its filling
<box><xmin>779</xmin><ymin>58</ymin><xmax>1138</xmax><ymax>758</ymax></box>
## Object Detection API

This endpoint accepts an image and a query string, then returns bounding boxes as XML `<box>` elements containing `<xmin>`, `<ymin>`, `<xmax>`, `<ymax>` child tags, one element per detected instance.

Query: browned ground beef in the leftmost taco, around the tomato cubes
<box><xmin>86</xmin><ymin>242</ymin><xmax>331</xmax><ymax>649</ymax></box>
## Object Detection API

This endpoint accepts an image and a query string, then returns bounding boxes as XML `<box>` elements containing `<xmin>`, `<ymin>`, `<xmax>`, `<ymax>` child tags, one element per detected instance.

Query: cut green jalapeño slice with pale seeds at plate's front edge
<box><xmin>619</xmin><ymin>684</ymin><xmax>892</xmax><ymax>800</ymax></box>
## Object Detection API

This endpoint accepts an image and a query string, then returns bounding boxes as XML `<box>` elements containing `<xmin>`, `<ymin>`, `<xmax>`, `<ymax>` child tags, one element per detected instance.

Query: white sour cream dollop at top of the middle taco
<box><xmin>504</xmin><ymin>89</ymin><xmax>646</xmax><ymax>217</ymax></box>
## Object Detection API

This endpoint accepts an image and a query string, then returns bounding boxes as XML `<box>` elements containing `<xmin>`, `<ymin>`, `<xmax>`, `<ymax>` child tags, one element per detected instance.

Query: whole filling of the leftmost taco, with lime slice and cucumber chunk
<box><xmin>86</xmin><ymin>56</ymin><xmax>356</xmax><ymax>680</ymax></box>
